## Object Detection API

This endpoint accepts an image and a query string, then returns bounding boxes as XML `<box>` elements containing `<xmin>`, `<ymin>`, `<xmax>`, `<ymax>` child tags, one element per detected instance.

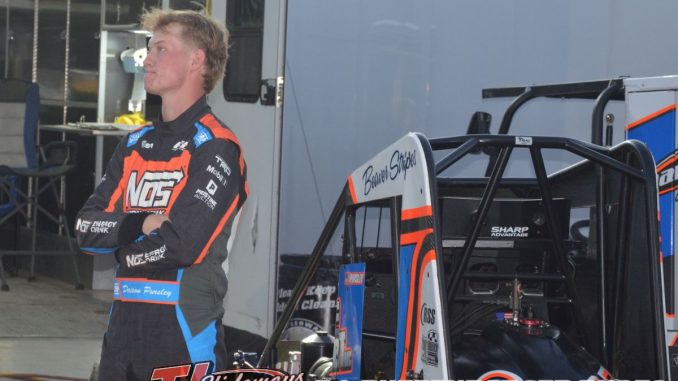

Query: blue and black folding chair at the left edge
<box><xmin>0</xmin><ymin>79</ymin><xmax>83</xmax><ymax>291</ymax></box>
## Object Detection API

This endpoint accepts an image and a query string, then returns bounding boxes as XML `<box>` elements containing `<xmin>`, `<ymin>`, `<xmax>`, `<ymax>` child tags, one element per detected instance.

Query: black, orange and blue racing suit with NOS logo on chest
<box><xmin>76</xmin><ymin>97</ymin><xmax>248</xmax><ymax>380</ymax></box>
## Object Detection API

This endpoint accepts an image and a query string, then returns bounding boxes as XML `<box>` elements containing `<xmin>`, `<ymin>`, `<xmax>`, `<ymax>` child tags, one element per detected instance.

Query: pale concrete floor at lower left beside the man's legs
<box><xmin>0</xmin><ymin>277</ymin><xmax>112</xmax><ymax>381</ymax></box>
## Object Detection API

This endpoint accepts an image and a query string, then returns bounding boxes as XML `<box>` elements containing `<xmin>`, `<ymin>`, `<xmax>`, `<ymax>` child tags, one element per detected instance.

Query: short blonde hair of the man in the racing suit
<box><xmin>141</xmin><ymin>8</ymin><xmax>229</xmax><ymax>94</ymax></box>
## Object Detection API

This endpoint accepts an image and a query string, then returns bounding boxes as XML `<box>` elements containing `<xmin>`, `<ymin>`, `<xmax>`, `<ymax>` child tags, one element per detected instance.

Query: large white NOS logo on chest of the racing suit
<box><xmin>126</xmin><ymin>171</ymin><xmax>184</xmax><ymax>209</ymax></box>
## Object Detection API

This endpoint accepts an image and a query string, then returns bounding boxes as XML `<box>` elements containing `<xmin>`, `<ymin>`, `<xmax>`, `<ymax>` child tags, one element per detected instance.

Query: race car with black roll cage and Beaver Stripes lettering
<box><xmin>258</xmin><ymin>129</ymin><xmax>670</xmax><ymax>380</ymax></box>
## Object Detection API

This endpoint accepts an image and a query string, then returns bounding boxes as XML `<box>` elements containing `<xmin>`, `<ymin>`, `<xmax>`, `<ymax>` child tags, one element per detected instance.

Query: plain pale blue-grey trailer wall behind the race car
<box><xmin>278</xmin><ymin>0</ymin><xmax>678</xmax><ymax>254</ymax></box>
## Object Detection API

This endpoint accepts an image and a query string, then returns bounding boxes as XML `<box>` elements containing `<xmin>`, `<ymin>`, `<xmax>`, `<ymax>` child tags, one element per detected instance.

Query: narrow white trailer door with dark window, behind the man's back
<box><xmin>208</xmin><ymin>0</ymin><xmax>287</xmax><ymax>338</ymax></box>
